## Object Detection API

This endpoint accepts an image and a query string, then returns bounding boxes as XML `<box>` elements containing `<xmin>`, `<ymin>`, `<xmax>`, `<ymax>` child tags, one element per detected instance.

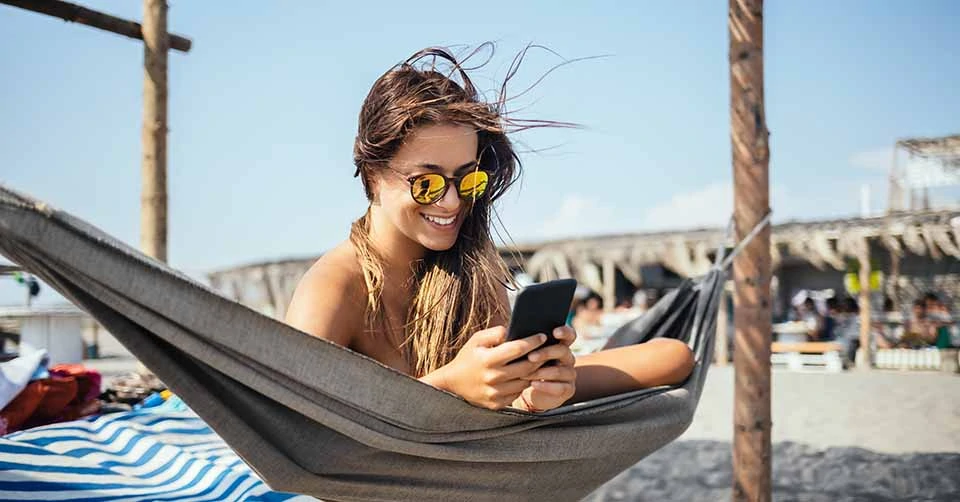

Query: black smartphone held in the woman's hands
<box><xmin>507</xmin><ymin>279</ymin><xmax>577</xmax><ymax>347</ymax></box>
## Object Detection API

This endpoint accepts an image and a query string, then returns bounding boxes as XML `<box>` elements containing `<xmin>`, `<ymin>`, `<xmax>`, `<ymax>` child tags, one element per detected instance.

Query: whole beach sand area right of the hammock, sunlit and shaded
<box><xmin>586</xmin><ymin>367</ymin><xmax>960</xmax><ymax>502</ymax></box>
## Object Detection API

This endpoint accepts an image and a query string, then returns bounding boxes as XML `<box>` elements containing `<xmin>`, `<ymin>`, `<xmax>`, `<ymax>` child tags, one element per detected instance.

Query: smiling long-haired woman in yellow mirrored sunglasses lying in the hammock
<box><xmin>287</xmin><ymin>49</ymin><xmax>693</xmax><ymax>412</ymax></box>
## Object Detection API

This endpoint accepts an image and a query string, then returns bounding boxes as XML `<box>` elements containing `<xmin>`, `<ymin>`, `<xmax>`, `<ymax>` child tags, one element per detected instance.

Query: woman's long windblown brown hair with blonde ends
<box><xmin>350</xmin><ymin>46</ymin><xmax>566</xmax><ymax>376</ymax></box>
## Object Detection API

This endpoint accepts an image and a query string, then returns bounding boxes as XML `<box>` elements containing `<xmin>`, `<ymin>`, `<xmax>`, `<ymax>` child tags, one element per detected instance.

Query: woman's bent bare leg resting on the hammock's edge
<box><xmin>569</xmin><ymin>338</ymin><xmax>695</xmax><ymax>403</ymax></box>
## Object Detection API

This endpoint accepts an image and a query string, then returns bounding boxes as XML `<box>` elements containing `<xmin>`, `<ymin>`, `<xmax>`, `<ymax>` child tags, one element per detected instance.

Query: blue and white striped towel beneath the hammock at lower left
<box><xmin>0</xmin><ymin>410</ymin><xmax>316</xmax><ymax>502</ymax></box>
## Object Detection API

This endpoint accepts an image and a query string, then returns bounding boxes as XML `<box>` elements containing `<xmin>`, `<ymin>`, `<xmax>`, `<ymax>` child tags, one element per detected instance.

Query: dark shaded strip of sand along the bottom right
<box><xmin>585</xmin><ymin>440</ymin><xmax>960</xmax><ymax>502</ymax></box>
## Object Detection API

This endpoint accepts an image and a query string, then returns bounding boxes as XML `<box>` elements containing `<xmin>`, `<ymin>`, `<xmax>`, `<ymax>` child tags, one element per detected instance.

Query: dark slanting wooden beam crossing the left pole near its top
<box><xmin>0</xmin><ymin>0</ymin><xmax>193</xmax><ymax>52</ymax></box>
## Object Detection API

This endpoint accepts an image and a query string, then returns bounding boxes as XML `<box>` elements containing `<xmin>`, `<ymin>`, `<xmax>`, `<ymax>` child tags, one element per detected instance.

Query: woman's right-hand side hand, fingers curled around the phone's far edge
<box><xmin>512</xmin><ymin>326</ymin><xmax>577</xmax><ymax>412</ymax></box>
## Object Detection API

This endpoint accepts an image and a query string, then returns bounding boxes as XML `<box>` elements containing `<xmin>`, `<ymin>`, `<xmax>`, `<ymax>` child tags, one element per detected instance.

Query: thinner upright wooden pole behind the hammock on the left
<box><xmin>140</xmin><ymin>0</ymin><xmax>170</xmax><ymax>261</ymax></box>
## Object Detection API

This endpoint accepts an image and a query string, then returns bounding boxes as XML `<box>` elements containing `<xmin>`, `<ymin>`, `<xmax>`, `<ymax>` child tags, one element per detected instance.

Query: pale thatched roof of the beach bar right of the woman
<box><xmin>508</xmin><ymin>211</ymin><xmax>960</xmax><ymax>287</ymax></box>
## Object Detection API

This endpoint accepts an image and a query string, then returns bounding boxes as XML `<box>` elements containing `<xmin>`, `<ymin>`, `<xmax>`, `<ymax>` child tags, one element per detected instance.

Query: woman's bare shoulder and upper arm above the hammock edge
<box><xmin>286</xmin><ymin>241</ymin><xmax>366</xmax><ymax>347</ymax></box>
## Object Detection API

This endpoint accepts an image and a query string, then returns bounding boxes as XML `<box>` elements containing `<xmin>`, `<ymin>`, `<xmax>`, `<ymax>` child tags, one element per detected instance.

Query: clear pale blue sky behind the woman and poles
<box><xmin>0</xmin><ymin>0</ymin><xmax>960</xmax><ymax>304</ymax></box>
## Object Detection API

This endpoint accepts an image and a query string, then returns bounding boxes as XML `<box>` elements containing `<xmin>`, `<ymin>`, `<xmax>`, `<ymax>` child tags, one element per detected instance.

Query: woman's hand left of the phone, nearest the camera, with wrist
<box><xmin>420</xmin><ymin>326</ymin><xmax>548</xmax><ymax>410</ymax></box>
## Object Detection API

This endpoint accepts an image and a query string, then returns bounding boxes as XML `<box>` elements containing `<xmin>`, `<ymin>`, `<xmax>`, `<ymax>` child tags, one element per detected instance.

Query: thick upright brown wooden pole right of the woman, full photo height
<box><xmin>728</xmin><ymin>0</ymin><xmax>772</xmax><ymax>501</ymax></box>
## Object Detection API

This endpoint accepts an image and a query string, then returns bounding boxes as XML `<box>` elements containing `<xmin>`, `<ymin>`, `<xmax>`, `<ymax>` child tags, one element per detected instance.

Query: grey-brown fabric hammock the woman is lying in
<box><xmin>0</xmin><ymin>187</ymin><xmax>723</xmax><ymax>501</ymax></box>
